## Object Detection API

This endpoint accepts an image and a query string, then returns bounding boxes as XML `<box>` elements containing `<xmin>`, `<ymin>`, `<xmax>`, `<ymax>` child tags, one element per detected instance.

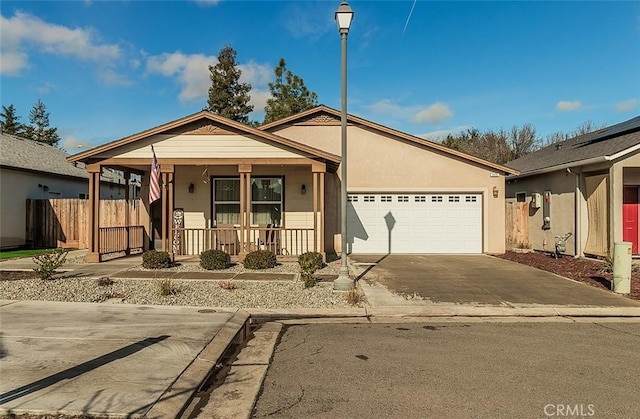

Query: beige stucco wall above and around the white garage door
<box><xmin>274</xmin><ymin>125</ymin><xmax>505</xmax><ymax>253</ymax></box>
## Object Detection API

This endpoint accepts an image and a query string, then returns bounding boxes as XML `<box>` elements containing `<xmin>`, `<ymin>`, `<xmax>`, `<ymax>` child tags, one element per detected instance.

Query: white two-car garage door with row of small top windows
<box><xmin>347</xmin><ymin>194</ymin><xmax>482</xmax><ymax>253</ymax></box>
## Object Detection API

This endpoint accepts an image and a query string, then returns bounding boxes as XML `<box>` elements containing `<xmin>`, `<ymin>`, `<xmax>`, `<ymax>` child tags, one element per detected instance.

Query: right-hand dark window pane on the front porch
<box><xmin>251</xmin><ymin>177</ymin><xmax>283</xmax><ymax>226</ymax></box>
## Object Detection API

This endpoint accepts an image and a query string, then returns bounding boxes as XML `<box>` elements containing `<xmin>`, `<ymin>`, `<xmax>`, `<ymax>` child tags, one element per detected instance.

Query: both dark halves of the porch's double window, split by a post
<box><xmin>213</xmin><ymin>177</ymin><xmax>283</xmax><ymax>225</ymax></box>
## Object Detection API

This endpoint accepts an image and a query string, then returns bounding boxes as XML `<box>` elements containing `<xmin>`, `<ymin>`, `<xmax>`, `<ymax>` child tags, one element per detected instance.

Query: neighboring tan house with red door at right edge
<box><xmin>507</xmin><ymin>116</ymin><xmax>640</xmax><ymax>256</ymax></box>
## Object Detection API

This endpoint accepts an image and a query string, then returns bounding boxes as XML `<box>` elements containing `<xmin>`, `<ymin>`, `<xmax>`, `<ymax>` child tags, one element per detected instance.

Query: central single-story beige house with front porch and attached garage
<box><xmin>69</xmin><ymin>106</ymin><xmax>517</xmax><ymax>261</ymax></box>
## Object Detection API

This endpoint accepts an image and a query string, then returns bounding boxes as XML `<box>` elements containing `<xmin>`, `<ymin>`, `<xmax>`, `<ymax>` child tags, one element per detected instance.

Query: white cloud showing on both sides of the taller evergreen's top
<box><xmin>147</xmin><ymin>51</ymin><xmax>273</xmax><ymax>106</ymax></box>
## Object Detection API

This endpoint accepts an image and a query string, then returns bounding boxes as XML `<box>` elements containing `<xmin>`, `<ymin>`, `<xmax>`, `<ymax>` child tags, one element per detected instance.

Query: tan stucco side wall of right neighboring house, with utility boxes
<box><xmin>507</xmin><ymin>171</ymin><xmax>576</xmax><ymax>255</ymax></box>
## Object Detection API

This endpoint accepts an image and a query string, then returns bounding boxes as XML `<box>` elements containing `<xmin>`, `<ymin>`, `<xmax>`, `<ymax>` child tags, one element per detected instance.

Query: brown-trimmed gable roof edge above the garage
<box><xmin>258</xmin><ymin>105</ymin><xmax>518</xmax><ymax>174</ymax></box>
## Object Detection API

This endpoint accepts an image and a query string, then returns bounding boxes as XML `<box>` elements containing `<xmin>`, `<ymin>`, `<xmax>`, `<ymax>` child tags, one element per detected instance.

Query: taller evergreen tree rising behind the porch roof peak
<box><xmin>205</xmin><ymin>45</ymin><xmax>253</xmax><ymax>124</ymax></box>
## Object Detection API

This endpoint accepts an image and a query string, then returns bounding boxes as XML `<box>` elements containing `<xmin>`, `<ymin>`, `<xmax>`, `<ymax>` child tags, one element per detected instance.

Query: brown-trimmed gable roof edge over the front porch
<box><xmin>67</xmin><ymin>111</ymin><xmax>341</xmax><ymax>163</ymax></box>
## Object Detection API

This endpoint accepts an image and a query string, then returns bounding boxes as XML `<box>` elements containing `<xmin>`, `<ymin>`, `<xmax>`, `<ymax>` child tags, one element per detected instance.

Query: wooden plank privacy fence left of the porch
<box><xmin>26</xmin><ymin>199</ymin><xmax>143</xmax><ymax>249</ymax></box>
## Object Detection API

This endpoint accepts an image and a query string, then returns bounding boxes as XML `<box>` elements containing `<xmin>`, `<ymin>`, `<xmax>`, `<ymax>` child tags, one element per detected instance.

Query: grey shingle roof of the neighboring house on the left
<box><xmin>0</xmin><ymin>133</ymin><xmax>89</xmax><ymax>179</ymax></box>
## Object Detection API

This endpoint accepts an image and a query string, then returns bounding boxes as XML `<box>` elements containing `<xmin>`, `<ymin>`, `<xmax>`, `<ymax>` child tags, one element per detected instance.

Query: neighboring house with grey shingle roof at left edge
<box><xmin>0</xmin><ymin>133</ymin><xmax>132</xmax><ymax>249</ymax></box>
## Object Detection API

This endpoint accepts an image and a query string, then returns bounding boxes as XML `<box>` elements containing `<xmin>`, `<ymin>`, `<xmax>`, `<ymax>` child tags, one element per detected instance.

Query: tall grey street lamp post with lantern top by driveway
<box><xmin>333</xmin><ymin>1</ymin><xmax>353</xmax><ymax>291</ymax></box>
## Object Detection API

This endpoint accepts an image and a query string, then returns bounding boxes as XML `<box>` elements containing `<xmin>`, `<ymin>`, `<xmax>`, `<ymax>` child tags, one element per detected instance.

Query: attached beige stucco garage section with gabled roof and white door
<box><xmin>260</xmin><ymin>106</ymin><xmax>517</xmax><ymax>254</ymax></box>
